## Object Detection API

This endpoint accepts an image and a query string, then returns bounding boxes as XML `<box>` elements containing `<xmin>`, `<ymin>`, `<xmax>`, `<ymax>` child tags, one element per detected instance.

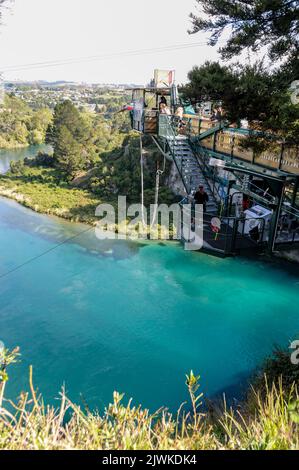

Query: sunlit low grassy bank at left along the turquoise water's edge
<box><xmin>0</xmin><ymin>167</ymin><xmax>106</xmax><ymax>224</ymax></box>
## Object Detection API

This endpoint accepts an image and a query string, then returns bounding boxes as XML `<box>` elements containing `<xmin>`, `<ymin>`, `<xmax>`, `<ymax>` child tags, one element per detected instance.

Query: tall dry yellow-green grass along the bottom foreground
<box><xmin>0</xmin><ymin>350</ymin><xmax>299</xmax><ymax>450</ymax></box>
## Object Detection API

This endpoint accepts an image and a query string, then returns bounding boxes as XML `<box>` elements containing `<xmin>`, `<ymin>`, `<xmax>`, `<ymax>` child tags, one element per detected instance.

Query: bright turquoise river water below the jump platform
<box><xmin>0</xmin><ymin>146</ymin><xmax>299</xmax><ymax>411</ymax></box>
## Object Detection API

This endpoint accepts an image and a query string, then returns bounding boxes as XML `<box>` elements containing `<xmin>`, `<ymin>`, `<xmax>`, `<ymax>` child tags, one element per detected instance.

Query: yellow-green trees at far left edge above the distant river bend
<box><xmin>0</xmin><ymin>95</ymin><xmax>52</xmax><ymax>148</ymax></box>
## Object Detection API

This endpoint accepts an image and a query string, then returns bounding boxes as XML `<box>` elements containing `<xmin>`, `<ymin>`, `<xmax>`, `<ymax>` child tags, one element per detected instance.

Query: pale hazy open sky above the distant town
<box><xmin>0</xmin><ymin>0</ymin><xmax>223</xmax><ymax>84</ymax></box>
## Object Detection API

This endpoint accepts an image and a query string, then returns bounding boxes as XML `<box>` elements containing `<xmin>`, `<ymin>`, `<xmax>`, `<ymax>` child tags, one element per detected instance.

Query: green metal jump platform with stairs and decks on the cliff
<box><xmin>131</xmin><ymin>81</ymin><xmax>299</xmax><ymax>255</ymax></box>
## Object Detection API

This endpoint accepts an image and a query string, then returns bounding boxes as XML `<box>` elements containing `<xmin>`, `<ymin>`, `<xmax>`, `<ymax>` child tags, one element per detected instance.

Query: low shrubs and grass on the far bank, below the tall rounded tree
<box><xmin>0</xmin><ymin>133</ymin><xmax>175</xmax><ymax>224</ymax></box>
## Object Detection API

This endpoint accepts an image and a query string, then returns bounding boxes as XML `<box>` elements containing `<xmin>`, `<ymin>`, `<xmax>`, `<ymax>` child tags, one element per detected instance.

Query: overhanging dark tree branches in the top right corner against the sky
<box><xmin>190</xmin><ymin>0</ymin><xmax>299</xmax><ymax>66</ymax></box>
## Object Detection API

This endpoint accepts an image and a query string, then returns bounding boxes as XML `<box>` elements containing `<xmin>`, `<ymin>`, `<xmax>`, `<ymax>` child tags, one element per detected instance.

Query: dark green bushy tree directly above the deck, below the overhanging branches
<box><xmin>182</xmin><ymin>62</ymin><xmax>299</xmax><ymax>142</ymax></box>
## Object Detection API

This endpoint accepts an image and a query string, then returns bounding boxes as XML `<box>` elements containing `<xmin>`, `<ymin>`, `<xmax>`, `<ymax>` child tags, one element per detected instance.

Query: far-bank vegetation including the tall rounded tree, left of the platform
<box><xmin>0</xmin><ymin>96</ymin><xmax>176</xmax><ymax>224</ymax></box>
